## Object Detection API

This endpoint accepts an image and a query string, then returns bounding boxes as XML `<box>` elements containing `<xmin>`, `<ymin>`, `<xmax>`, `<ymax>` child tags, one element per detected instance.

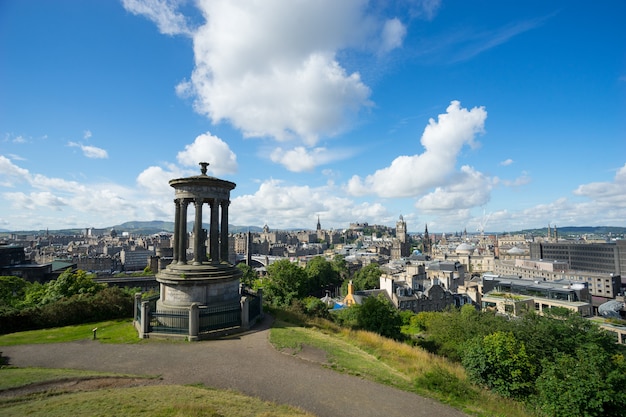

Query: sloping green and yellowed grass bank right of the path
<box><xmin>270</xmin><ymin>316</ymin><xmax>533</xmax><ymax>417</ymax></box>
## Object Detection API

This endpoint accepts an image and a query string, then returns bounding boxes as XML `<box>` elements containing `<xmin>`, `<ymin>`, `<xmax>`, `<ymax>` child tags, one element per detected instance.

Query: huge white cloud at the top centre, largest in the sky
<box><xmin>177</xmin><ymin>0</ymin><xmax>378</xmax><ymax>146</ymax></box>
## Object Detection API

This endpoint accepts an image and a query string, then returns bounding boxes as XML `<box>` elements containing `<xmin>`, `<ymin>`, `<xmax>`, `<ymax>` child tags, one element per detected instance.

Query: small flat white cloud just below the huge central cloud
<box><xmin>270</xmin><ymin>146</ymin><xmax>350</xmax><ymax>172</ymax></box>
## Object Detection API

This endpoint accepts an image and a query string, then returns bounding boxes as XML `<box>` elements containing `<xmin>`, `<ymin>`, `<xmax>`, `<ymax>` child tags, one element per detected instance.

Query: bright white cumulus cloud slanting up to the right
<box><xmin>347</xmin><ymin>101</ymin><xmax>487</xmax><ymax>197</ymax></box>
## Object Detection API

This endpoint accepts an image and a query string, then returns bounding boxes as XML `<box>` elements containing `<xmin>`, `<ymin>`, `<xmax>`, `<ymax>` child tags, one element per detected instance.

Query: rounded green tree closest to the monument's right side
<box><xmin>265</xmin><ymin>259</ymin><xmax>308</xmax><ymax>306</ymax></box>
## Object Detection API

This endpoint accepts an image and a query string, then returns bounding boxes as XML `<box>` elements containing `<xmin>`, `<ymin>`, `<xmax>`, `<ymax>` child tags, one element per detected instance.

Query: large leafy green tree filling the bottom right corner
<box><xmin>536</xmin><ymin>344</ymin><xmax>626</xmax><ymax>417</ymax></box>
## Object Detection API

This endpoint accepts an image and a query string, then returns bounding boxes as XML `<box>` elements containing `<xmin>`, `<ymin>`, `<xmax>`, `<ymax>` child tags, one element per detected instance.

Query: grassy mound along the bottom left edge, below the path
<box><xmin>0</xmin><ymin>385</ymin><xmax>313</xmax><ymax>417</ymax></box>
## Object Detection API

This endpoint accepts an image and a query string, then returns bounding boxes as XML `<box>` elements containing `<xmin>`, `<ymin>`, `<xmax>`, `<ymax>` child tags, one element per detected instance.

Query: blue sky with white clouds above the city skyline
<box><xmin>0</xmin><ymin>0</ymin><xmax>626</xmax><ymax>232</ymax></box>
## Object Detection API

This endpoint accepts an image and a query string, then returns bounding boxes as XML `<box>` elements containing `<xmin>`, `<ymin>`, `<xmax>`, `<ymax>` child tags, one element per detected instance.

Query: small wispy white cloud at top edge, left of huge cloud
<box><xmin>122</xmin><ymin>0</ymin><xmax>191</xmax><ymax>35</ymax></box>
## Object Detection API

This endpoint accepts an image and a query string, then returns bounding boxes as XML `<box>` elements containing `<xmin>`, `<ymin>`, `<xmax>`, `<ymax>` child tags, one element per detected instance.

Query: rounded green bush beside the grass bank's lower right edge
<box><xmin>463</xmin><ymin>331</ymin><xmax>536</xmax><ymax>399</ymax></box>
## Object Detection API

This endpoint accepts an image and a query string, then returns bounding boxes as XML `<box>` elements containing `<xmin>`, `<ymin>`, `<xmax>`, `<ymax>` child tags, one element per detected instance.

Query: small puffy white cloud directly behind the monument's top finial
<box><xmin>176</xmin><ymin>132</ymin><xmax>237</xmax><ymax>175</ymax></box>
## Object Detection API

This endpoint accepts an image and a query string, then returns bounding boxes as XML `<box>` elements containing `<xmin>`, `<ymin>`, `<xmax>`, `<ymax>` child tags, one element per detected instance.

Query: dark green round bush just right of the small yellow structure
<box><xmin>351</xmin><ymin>294</ymin><xmax>402</xmax><ymax>339</ymax></box>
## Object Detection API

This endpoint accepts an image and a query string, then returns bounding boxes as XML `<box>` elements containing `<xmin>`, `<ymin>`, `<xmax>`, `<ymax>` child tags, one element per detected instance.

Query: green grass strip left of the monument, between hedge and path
<box><xmin>0</xmin><ymin>319</ymin><xmax>142</xmax><ymax>346</ymax></box>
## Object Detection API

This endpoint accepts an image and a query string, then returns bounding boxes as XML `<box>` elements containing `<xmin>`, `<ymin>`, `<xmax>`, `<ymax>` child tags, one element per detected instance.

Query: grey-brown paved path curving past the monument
<box><xmin>1</xmin><ymin>316</ymin><xmax>464</xmax><ymax>417</ymax></box>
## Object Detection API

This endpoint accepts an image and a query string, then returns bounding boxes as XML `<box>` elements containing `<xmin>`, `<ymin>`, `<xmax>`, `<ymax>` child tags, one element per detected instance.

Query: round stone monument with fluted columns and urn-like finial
<box><xmin>156</xmin><ymin>162</ymin><xmax>241</xmax><ymax>311</ymax></box>
